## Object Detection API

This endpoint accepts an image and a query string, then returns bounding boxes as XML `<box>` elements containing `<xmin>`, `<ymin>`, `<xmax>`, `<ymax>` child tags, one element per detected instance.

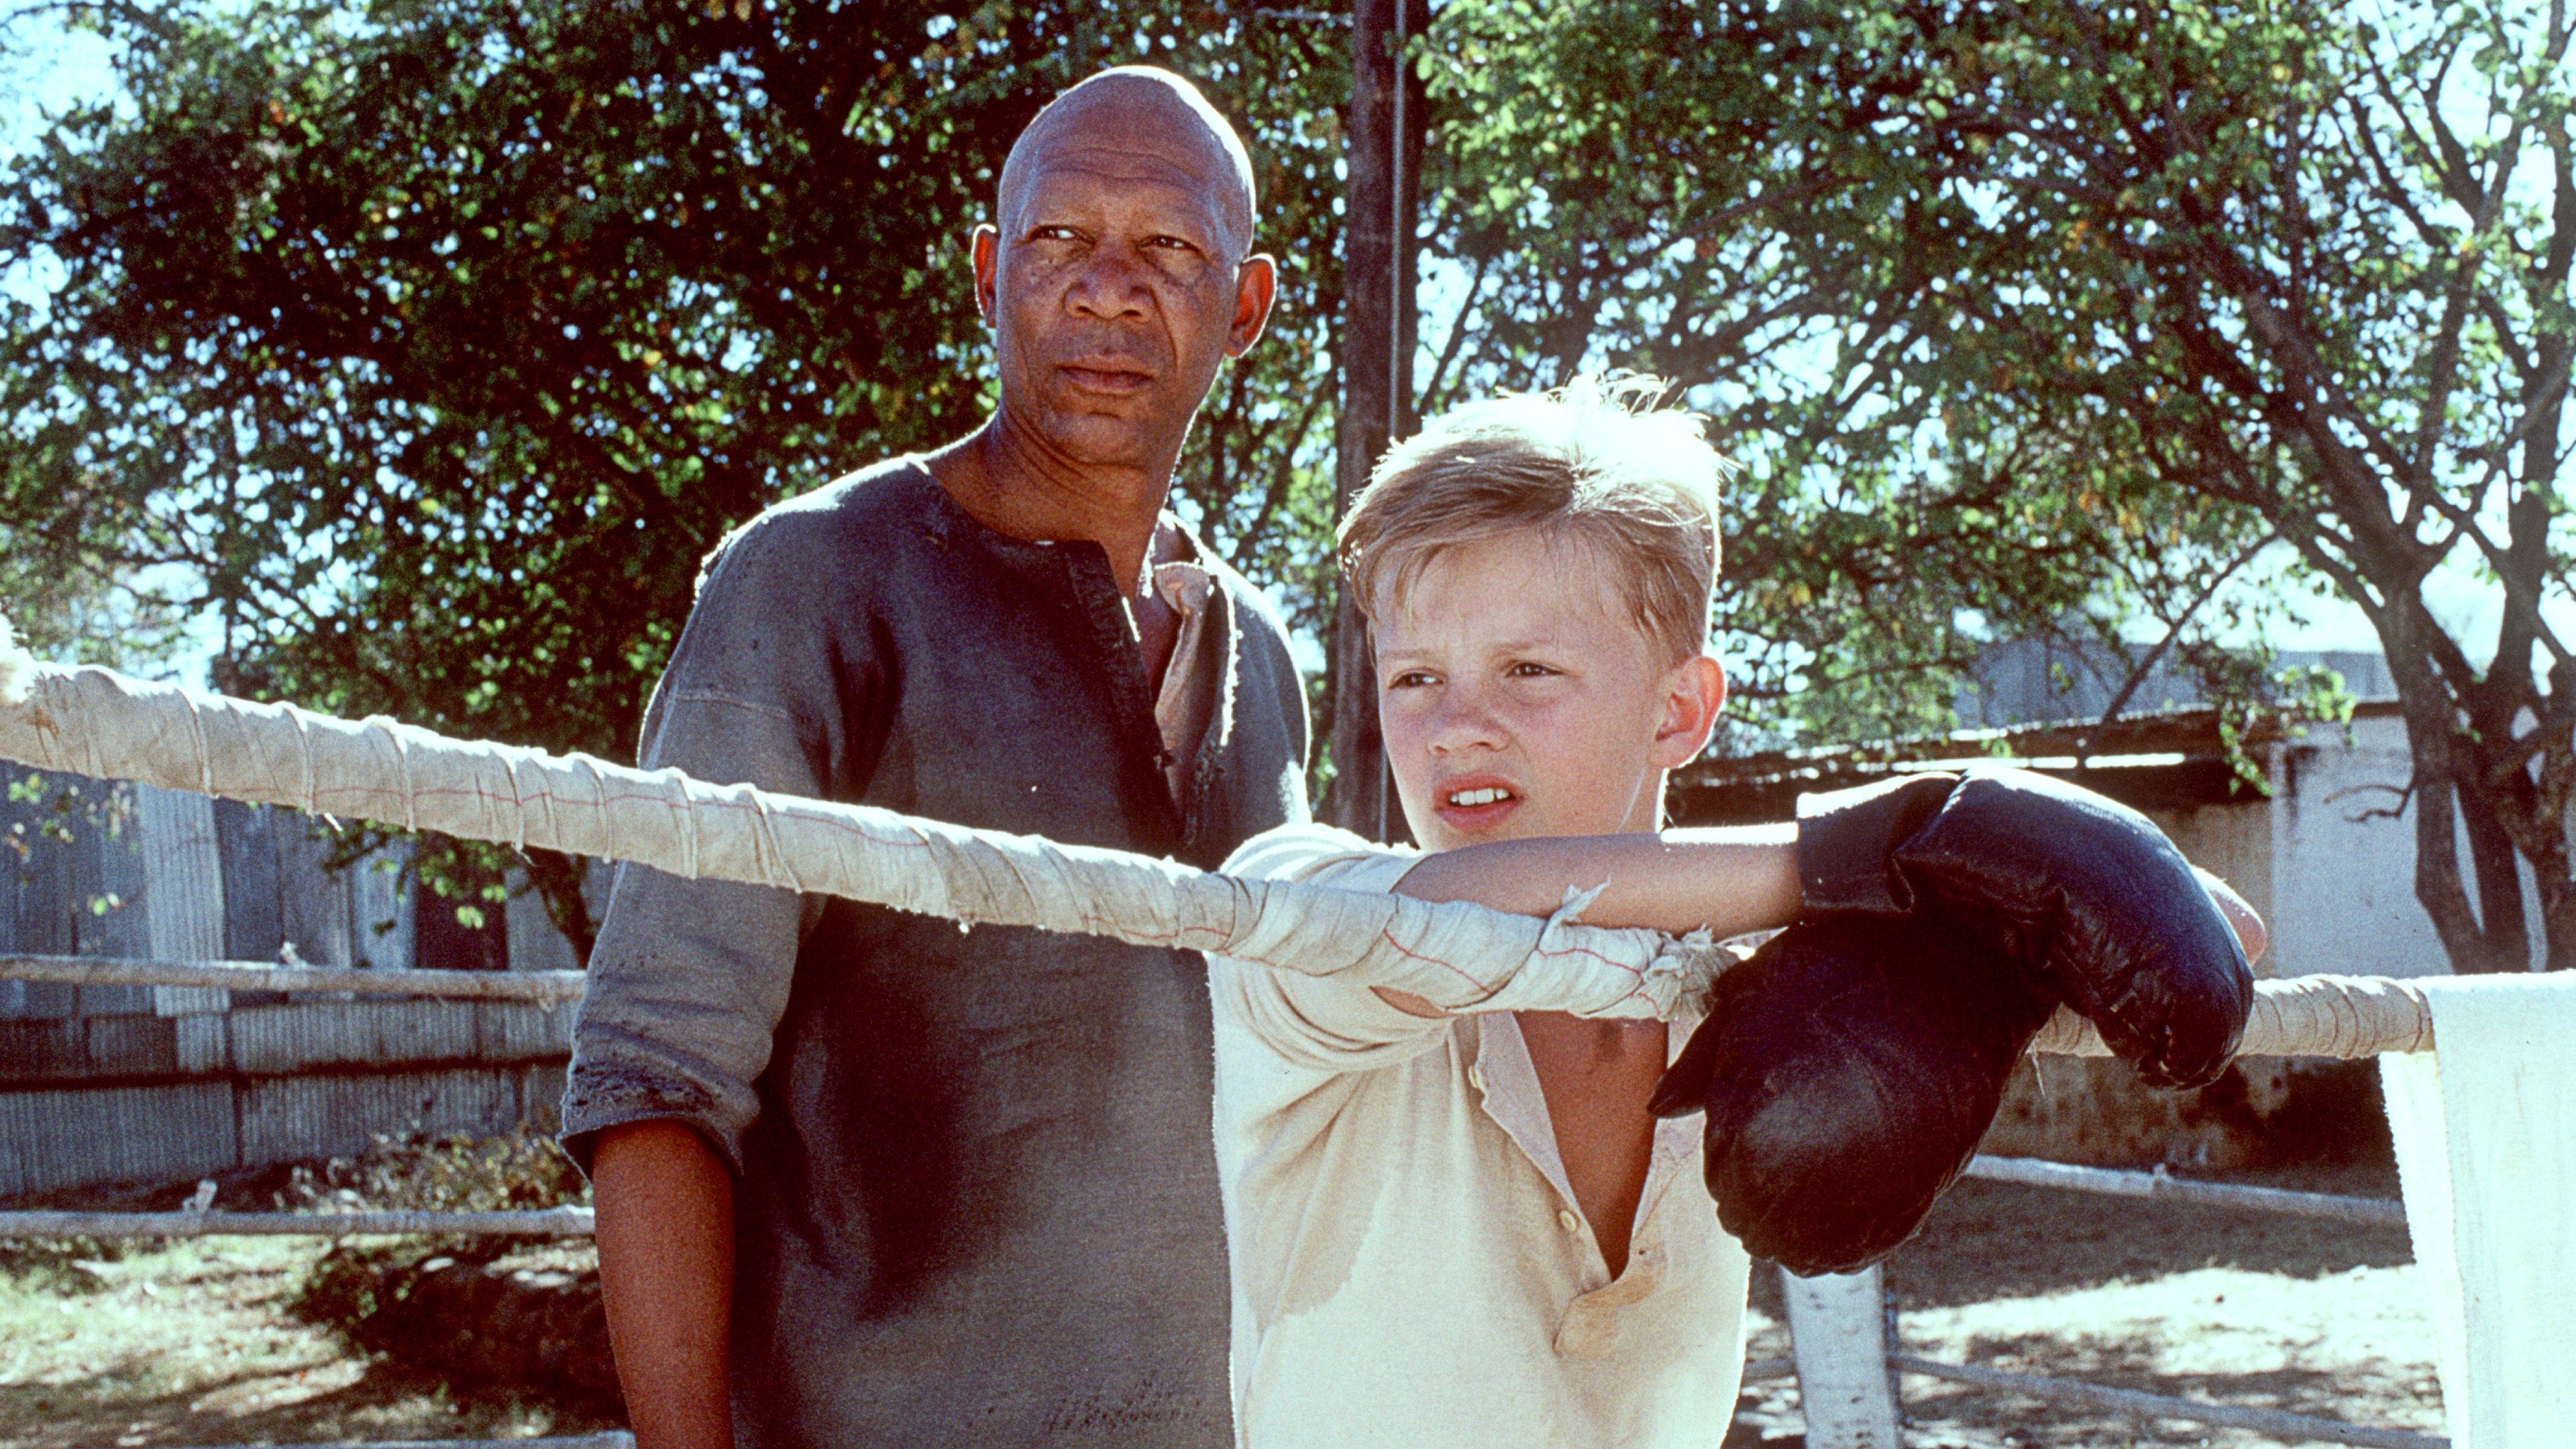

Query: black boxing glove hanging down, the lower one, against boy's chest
<box><xmin>1651</xmin><ymin>913</ymin><xmax>2058</xmax><ymax>1274</ymax></box>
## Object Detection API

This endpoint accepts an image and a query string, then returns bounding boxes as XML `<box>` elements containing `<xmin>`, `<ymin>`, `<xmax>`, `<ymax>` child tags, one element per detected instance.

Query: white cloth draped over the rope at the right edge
<box><xmin>2380</xmin><ymin>972</ymin><xmax>2576</xmax><ymax>1449</ymax></box>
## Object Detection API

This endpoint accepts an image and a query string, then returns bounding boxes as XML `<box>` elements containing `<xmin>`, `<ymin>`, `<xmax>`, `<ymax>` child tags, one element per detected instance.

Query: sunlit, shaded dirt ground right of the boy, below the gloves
<box><xmin>1729</xmin><ymin>1168</ymin><xmax>2442</xmax><ymax>1449</ymax></box>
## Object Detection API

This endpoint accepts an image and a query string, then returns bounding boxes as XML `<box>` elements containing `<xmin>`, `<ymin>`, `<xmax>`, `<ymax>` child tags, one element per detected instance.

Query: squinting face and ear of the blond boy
<box><xmin>1376</xmin><ymin>531</ymin><xmax>1726</xmax><ymax>851</ymax></box>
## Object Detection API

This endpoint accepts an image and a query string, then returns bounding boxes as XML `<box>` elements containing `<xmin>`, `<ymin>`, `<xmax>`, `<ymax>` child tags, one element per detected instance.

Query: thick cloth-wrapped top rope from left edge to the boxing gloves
<box><xmin>0</xmin><ymin>665</ymin><xmax>1731</xmax><ymax>1018</ymax></box>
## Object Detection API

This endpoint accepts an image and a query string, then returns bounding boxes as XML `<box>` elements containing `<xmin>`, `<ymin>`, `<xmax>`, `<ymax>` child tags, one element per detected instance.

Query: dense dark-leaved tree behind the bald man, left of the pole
<box><xmin>0</xmin><ymin>0</ymin><xmax>1347</xmax><ymax>947</ymax></box>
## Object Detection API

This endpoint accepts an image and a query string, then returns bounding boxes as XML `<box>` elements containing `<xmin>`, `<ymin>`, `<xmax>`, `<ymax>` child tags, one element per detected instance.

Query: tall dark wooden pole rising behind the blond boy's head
<box><xmin>1324</xmin><ymin>0</ymin><xmax>1430</xmax><ymax>841</ymax></box>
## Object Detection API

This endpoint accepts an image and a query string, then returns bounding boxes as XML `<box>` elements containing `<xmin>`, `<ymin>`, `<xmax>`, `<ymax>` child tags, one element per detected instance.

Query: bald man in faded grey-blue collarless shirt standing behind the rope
<box><xmin>564</xmin><ymin>70</ymin><xmax>1306</xmax><ymax>1449</ymax></box>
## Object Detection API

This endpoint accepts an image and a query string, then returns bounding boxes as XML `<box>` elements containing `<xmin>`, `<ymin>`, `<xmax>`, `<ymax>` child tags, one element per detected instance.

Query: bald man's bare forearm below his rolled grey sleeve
<box><xmin>590</xmin><ymin>1119</ymin><xmax>734</xmax><ymax>1449</ymax></box>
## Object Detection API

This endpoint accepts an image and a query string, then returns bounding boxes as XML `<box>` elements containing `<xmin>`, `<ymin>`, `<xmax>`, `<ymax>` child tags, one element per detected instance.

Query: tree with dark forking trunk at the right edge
<box><xmin>1690</xmin><ymin>0</ymin><xmax>2576</xmax><ymax>972</ymax></box>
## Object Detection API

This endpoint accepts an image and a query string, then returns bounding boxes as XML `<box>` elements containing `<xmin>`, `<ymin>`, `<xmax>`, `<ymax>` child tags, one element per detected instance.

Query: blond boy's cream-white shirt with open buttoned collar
<box><xmin>1208</xmin><ymin>825</ymin><xmax>1749</xmax><ymax>1449</ymax></box>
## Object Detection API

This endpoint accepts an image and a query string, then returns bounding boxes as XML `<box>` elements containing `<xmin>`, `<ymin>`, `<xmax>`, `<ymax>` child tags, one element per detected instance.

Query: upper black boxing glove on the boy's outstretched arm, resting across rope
<box><xmin>1798</xmin><ymin>768</ymin><xmax>2254</xmax><ymax>1088</ymax></box>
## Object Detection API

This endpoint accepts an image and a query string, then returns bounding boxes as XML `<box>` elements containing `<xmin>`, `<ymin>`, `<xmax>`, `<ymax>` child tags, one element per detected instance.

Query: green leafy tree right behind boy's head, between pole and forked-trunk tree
<box><xmin>1422</xmin><ymin>0</ymin><xmax>2269</xmax><ymax>743</ymax></box>
